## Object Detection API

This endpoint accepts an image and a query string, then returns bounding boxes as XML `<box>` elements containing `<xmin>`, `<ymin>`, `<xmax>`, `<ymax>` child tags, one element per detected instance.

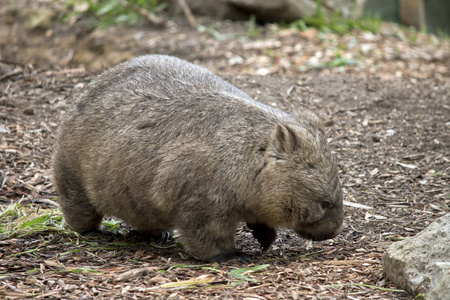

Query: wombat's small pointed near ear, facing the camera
<box><xmin>270</xmin><ymin>124</ymin><xmax>300</xmax><ymax>154</ymax></box>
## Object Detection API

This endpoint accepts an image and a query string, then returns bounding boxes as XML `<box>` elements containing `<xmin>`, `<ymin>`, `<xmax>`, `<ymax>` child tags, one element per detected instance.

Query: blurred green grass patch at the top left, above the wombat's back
<box><xmin>65</xmin><ymin>0</ymin><xmax>167</xmax><ymax>28</ymax></box>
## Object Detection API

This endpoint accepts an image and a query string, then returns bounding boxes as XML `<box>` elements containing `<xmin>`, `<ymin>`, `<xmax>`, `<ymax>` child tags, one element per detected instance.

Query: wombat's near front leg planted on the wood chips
<box><xmin>180</xmin><ymin>216</ymin><xmax>251</xmax><ymax>262</ymax></box>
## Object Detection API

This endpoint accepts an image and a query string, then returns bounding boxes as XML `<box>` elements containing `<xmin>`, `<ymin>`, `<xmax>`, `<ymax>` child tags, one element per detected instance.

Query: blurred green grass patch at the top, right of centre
<box><xmin>288</xmin><ymin>0</ymin><xmax>382</xmax><ymax>34</ymax></box>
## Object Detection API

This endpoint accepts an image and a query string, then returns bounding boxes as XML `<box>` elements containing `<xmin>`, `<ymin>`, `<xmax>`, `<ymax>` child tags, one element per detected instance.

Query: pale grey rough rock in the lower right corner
<box><xmin>383</xmin><ymin>214</ymin><xmax>450</xmax><ymax>299</ymax></box>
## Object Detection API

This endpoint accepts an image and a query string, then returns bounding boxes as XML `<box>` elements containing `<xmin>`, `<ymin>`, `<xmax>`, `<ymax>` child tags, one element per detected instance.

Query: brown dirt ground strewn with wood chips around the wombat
<box><xmin>0</xmin><ymin>2</ymin><xmax>450</xmax><ymax>299</ymax></box>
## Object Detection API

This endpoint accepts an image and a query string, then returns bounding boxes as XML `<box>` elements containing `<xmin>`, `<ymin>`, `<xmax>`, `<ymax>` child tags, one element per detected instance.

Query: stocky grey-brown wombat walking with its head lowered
<box><xmin>53</xmin><ymin>55</ymin><xmax>343</xmax><ymax>262</ymax></box>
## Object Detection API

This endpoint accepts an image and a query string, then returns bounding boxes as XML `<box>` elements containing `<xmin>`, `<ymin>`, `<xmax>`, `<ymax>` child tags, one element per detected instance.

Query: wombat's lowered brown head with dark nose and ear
<box><xmin>261</xmin><ymin>111</ymin><xmax>343</xmax><ymax>240</ymax></box>
